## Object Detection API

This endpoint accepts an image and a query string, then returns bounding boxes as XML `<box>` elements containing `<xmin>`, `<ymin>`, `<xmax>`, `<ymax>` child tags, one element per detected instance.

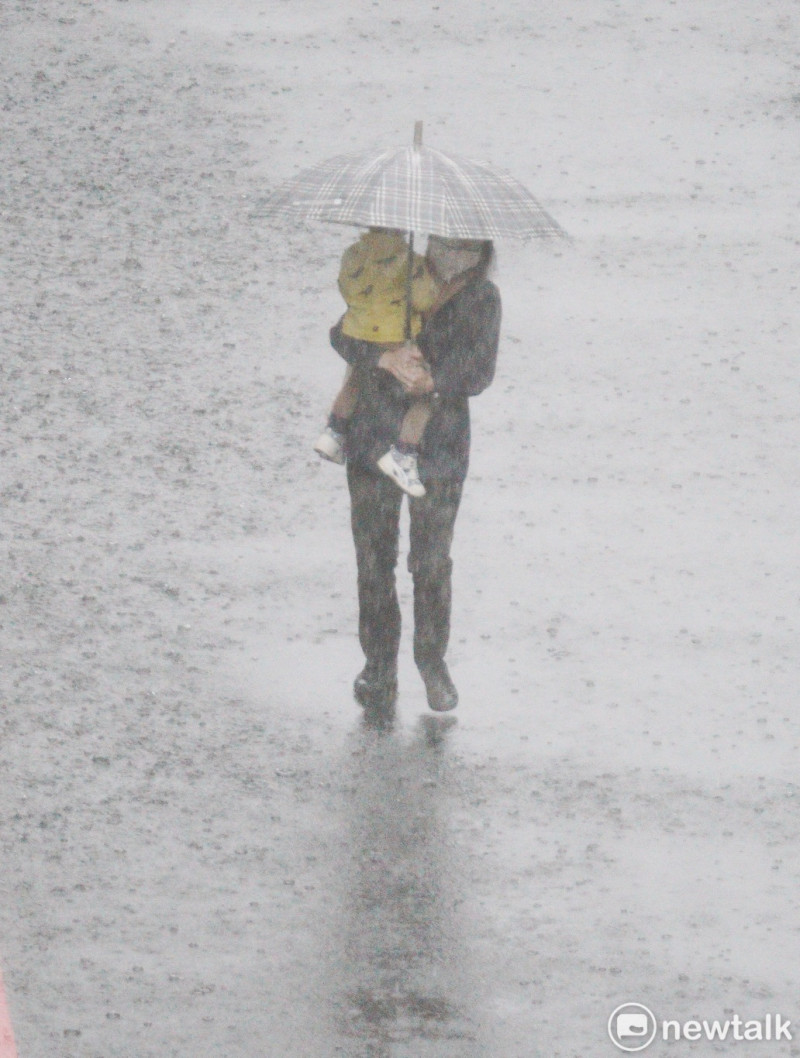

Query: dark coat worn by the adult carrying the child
<box><xmin>330</xmin><ymin>278</ymin><xmax>501</xmax><ymax>481</ymax></box>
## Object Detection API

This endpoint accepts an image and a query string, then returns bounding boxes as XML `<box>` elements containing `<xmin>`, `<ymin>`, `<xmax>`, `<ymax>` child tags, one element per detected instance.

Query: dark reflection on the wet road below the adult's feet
<box><xmin>331</xmin><ymin>716</ymin><xmax>487</xmax><ymax>1058</ymax></box>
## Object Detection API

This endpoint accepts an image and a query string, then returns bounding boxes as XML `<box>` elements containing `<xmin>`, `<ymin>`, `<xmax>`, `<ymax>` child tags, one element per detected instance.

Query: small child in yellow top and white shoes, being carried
<box><xmin>314</xmin><ymin>227</ymin><xmax>438</xmax><ymax>496</ymax></box>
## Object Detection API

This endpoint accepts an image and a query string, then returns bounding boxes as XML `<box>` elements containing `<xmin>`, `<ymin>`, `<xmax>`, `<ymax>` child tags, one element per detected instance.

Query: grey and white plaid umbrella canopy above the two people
<box><xmin>259</xmin><ymin>122</ymin><xmax>566</xmax><ymax>239</ymax></box>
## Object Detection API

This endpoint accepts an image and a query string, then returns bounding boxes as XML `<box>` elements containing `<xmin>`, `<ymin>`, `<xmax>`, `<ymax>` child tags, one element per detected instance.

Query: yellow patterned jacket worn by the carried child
<box><xmin>339</xmin><ymin>230</ymin><xmax>438</xmax><ymax>344</ymax></box>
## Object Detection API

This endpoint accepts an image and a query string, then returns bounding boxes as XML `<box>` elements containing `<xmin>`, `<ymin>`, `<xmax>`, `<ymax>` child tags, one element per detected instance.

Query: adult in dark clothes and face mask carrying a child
<box><xmin>330</xmin><ymin>234</ymin><xmax>502</xmax><ymax>716</ymax></box>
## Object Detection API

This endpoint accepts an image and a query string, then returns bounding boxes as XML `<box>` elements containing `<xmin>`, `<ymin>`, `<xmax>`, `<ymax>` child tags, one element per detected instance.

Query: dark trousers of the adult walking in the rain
<box><xmin>347</xmin><ymin>462</ymin><xmax>462</xmax><ymax>669</ymax></box>
